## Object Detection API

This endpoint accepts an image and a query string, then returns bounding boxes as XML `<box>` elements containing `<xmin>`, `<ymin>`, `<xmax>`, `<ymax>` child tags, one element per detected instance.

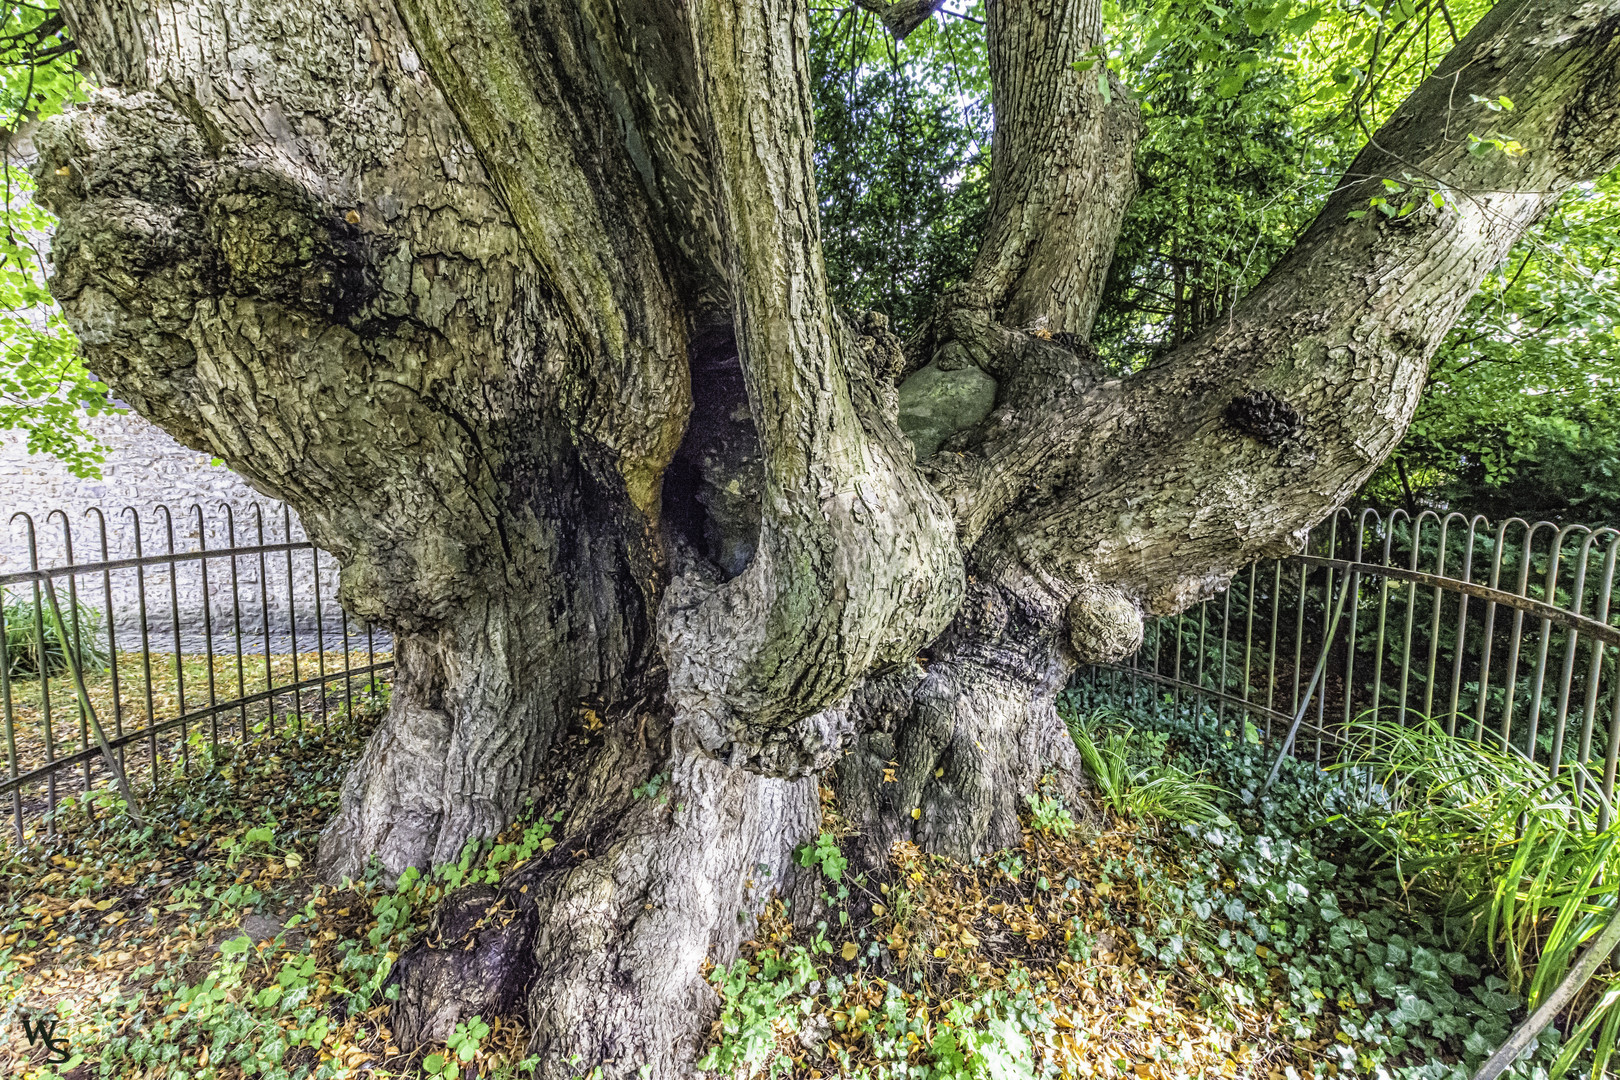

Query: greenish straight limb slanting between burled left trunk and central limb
<box><xmin>358</xmin><ymin>0</ymin><xmax>726</xmax><ymax>527</ymax></box>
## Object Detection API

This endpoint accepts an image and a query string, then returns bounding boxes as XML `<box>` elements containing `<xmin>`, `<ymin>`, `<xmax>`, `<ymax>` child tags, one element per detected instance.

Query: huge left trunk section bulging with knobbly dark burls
<box><xmin>37</xmin><ymin>0</ymin><xmax>685</xmax><ymax>873</ymax></box>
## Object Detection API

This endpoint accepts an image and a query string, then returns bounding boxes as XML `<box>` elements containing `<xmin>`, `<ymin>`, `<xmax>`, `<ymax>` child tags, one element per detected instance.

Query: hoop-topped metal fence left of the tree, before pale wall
<box><xmin>0</xmin><ymin>504</ymin><xmax>392</xmax><ymax>842</ymax></box>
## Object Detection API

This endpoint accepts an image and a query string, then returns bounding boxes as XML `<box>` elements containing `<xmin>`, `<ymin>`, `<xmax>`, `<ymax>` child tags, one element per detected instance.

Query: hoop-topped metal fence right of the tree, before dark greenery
<box><xmin>1082</xmin><ymin>510</ymin><xmax>1620</xmax><ymax>821</ymax></box>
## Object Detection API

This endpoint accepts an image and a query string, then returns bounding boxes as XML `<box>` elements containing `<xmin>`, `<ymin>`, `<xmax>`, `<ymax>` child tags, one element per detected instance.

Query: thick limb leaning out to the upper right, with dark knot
<box><xmin>941</xmin><ymin>0</ymin><xmax>1620</xmax><ymax>612</ymax></box>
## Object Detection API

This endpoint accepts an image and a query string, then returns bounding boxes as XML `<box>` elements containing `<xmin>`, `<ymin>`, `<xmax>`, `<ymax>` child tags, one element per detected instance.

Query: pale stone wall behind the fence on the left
<box><xmin>0</xmin><ymin>413</ymin><xmax>365</xmax><ymax>653</ymax></box>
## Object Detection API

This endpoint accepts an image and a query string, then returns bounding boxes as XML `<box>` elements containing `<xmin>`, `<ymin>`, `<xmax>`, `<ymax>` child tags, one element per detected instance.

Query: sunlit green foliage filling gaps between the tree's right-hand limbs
<box><xmin>812</xmin><ymin>0</ymin><xmax>1620</xmax><ymax>521</ymax></box>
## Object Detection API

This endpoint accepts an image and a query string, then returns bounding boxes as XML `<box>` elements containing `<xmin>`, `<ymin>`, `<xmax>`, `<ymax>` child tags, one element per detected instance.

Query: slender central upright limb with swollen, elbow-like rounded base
<box><xmin>661</xmin><ymin>0</ymin><xmax>962</xmax><ymax>774</ymax></box>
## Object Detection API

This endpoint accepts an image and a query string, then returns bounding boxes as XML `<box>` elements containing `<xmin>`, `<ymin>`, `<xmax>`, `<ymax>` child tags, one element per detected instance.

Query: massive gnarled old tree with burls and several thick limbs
<box><xmin>37</xmin><ymin>0</ymin><xmax>1620</xmax><ymax>1077</ymax></box>
